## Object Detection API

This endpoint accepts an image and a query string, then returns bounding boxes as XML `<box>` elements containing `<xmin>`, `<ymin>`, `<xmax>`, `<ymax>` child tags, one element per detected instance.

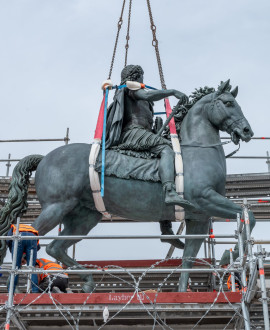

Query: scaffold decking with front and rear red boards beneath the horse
<box><xmin>0</xmin><ymin>259</ymin><xmax>270</xmax><ymax>330</ymax></box>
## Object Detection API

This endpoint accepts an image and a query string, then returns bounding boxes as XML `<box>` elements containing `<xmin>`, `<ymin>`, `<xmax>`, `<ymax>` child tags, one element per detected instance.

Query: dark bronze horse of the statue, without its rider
<box><xmin>0</xmin><ymin>80</ymin><xmax>255</xmax><ymax>292</ymax></box>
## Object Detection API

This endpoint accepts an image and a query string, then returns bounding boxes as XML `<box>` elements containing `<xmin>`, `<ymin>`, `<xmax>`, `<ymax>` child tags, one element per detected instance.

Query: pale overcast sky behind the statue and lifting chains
<box><xmin>0</xmin><ymin>0</ymin><xmax>270</xmax><ymax>259</ymax></box>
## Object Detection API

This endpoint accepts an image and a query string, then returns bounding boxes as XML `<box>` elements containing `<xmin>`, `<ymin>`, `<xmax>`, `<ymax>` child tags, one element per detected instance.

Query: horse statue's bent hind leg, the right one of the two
<box><xmin>46</xmin><ymin>207</ymin><xmax>102</xmax><ymax>292</ymax></box>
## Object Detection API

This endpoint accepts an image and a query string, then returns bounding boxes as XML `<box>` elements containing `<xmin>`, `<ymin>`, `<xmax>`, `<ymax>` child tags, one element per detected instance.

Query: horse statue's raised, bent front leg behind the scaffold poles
<box><xmin>196</xmin><ymin>189</ymin><xmax>256</xmax><ymax>265</ymax></box>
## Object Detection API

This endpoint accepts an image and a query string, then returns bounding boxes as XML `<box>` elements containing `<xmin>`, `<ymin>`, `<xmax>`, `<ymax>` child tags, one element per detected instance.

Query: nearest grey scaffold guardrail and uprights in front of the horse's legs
<box><xmin>0</xmin><ymin>200</ymin><xmax>269</xmax><ymax>330</ymax></box>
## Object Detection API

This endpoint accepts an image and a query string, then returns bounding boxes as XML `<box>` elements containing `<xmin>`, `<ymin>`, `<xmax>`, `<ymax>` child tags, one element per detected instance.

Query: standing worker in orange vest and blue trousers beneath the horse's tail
<box><xmin>7</xmin><ymin>224</ymin><xmax>40</xmax><ymax>293</ymax></box>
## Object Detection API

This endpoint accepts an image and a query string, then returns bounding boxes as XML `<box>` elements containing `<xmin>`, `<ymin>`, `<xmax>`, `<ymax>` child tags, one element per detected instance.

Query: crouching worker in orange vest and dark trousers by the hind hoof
<box><xmin>36</xmin><ymin>258</ymin><xmax>72</xmax><ymax>293</ymax></box>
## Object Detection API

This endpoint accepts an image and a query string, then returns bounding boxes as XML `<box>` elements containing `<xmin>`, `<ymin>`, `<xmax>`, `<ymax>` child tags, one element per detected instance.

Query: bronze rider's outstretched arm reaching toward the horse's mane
<box><xmin>133</xmin><ymin>89</ymin><xmax>187</xmax><ymax>102</ymax></box>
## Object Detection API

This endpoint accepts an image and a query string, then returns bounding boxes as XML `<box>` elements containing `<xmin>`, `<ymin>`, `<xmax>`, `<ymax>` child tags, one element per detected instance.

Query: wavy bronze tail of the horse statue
<box><xmin>0</xmin><ymin>155</ymin><xmax>43</xmax><ymax>265</ymax></box>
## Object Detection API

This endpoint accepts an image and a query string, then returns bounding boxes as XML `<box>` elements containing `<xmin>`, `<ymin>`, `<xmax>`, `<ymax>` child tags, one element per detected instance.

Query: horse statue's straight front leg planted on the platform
<box><xmin>178</xmin><ymin>218</ymin><xmax>209</xmax><ymax>292</ymax></box>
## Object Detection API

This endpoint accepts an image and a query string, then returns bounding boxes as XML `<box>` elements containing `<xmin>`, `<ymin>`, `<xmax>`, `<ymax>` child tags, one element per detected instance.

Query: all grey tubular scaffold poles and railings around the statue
<box><xmin>0</xmin><ymin>135</ymin><xmax>270</xmax><ymax>329</ymax></box>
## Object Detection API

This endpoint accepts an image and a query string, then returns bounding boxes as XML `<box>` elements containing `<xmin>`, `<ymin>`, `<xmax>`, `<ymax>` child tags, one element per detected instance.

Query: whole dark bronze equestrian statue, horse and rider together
<box><xmin>0</xmin><ymin>67</ymin><xmax>255</xmax><ymax>292</ymax></box>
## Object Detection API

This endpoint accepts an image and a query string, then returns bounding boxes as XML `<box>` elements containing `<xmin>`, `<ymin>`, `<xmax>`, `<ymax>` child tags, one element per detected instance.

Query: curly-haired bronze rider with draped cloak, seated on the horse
<box><xmin>106</xmin><ymin>65</ymin><xmax>193</xmax><ymax>209</ymax></box>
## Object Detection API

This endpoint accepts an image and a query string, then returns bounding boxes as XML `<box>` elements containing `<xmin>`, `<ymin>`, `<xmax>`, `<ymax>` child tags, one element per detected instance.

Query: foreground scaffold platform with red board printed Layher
<box><xmin>0</xmin><ymin>292</ymin><xmax>241</xmax><ymax>330</ymax></box>
